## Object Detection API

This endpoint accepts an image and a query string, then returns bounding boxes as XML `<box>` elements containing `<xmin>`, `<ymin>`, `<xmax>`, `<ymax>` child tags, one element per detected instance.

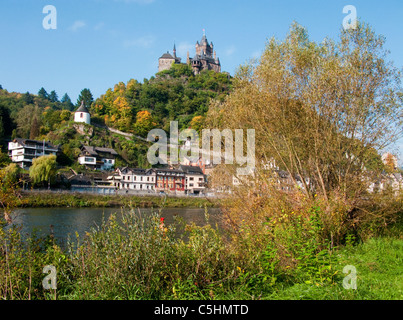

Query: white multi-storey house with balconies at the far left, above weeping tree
<box><xmin>8</xmin><ymin>138</ymin><xmax>59</xmax><ymax>169</ymax></box>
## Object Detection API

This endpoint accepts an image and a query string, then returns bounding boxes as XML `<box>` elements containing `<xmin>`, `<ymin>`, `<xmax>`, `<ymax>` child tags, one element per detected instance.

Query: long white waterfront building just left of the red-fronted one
<box><xmin>109</xmin><ymin>167</ymin><xmax>156</xmax><ymax>191</ymax></box>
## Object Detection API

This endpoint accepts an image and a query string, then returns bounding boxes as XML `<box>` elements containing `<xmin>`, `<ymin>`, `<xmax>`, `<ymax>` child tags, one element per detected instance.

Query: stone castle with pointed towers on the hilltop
<box><xmin>158</xmin><ymin>31</ymin><xmax>221</xmax><ymax>74</ymax></box>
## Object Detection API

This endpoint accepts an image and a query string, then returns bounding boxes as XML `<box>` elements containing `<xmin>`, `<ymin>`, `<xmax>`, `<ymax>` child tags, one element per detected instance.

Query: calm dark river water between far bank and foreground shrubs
<box><xmin>9</xmin><ymin>208</ymin><xmax>220</xmax><ymax>244</ymax></box>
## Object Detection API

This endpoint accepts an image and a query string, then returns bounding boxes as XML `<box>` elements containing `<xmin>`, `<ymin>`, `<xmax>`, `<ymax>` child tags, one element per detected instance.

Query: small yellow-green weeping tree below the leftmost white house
<box><xmin>29</xmin><ymin>155</ymin><xmax>57</xmax><ymax>189</ymax></box>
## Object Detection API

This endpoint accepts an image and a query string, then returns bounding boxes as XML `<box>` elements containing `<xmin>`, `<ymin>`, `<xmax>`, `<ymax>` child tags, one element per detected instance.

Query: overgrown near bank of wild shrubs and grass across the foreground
<box><xmin>0</xmin><ymin>208</ymin><xmax>403</xmax><ymax>300</ymax></box>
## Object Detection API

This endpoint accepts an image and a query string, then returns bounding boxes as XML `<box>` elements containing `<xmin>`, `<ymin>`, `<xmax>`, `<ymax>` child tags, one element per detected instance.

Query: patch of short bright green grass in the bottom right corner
<box><xmin>256</xmin><ymin>231</ymin><xmax>403</xmax><ymax>300</ymax></box>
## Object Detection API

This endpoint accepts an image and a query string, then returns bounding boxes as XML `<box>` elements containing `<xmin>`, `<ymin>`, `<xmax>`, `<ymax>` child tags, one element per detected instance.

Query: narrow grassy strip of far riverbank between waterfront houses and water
<box><xmin>17</xmin><ymin>192</ymin><xmax>218</xmax><ymax>208</ymax></box>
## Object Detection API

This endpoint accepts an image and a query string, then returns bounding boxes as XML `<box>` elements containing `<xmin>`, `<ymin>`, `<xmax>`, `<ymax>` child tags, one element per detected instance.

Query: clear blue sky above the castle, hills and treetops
<box><xmin>0</xmin><ymin>0</ymin><xmax>403</xmax><ymax>162</ymax></box>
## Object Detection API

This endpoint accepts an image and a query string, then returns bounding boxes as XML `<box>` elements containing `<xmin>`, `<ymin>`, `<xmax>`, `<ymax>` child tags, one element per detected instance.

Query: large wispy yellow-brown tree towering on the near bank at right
<box><xmin>208</xmin><ymin>23</ymin><xmax>402</xmax><ymax>201</ymax></box>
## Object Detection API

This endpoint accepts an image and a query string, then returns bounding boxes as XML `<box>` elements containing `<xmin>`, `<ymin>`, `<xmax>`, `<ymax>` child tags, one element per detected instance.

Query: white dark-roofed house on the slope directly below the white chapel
<box><xmin>78</xmin><ymin>146</ymin><xmax>118</xmax><ymax>171</ymax></box>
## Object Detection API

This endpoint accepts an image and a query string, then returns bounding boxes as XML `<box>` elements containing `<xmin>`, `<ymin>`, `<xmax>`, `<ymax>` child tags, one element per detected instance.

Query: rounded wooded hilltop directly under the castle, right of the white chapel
<box><xmin>91</xmin><ymin>65</ymin><xmax>231</xmax><ymax>136</ymax></box>
